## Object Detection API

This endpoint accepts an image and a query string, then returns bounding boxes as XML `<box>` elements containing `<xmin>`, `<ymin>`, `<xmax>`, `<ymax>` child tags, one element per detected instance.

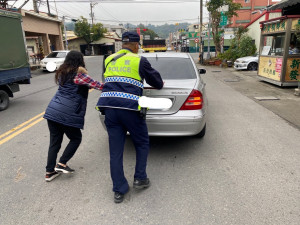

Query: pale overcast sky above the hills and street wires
<box><xmin>10</xmin><ymin>0</ymin><xmax>208</xmax><ymax>25</ymax></box>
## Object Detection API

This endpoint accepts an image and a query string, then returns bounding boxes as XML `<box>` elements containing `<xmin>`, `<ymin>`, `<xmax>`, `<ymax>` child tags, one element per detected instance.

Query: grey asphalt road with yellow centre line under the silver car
<box><xmin>0</xmin><ymin>57</ymin><xmax>300</xmax><ymax>225</ymax></box>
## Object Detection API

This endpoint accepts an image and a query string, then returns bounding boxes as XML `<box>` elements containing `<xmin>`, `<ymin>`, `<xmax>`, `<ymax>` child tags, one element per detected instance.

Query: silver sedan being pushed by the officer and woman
<box><xmin>100</xmin><ymin>52</ymin><xmax>207</xmax><ymax>137</ymax></box>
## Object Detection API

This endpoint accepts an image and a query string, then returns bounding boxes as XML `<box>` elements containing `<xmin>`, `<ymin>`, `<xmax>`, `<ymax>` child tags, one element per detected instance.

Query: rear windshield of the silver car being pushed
<box><xmin>147</xmin><ymin>57</ymin><xmax>197</xmax><ymax>80</ymax></box>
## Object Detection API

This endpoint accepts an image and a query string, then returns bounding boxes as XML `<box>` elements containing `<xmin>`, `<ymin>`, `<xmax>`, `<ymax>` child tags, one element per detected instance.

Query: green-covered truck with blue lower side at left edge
<box><xmin>0</xmin><ymin>9</ymin><xmax>31</xmax><ymax>111</ymax></box>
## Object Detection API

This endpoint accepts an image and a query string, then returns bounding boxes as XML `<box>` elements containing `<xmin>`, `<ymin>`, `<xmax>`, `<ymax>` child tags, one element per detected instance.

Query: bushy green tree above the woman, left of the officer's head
<box><xmin>74</xmin><ymin>16</ymin><xmax>107</xmax><ymax>49</ymax></box>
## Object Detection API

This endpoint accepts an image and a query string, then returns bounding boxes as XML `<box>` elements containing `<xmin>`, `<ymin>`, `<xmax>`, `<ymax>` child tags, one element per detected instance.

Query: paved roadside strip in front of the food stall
<box><xmin>191</xmin><ymin>53</ymin><xmax>300</xmax><ymax>130</ymax></box>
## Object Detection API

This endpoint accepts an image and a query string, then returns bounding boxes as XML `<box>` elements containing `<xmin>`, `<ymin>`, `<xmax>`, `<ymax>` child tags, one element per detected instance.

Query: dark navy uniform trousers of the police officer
<box><xmin>105</xmin><ymin>108</ymin><xmax>149</xmax><ymax>194</ymax></box>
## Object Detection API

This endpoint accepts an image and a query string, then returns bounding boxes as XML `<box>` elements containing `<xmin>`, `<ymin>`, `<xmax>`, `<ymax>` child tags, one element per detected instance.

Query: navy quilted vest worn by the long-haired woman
<box><xmin>44</xmin><ymin>79</ymin><xmax>89</xmax><ymax>129</ymax></box>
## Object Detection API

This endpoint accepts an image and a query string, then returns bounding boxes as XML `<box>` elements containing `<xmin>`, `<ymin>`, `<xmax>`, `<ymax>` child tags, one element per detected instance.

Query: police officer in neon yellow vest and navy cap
<box><xmin>97</xmin><ymin>32</ymin><xmax>163</xmax><ymax>203</ymax></box>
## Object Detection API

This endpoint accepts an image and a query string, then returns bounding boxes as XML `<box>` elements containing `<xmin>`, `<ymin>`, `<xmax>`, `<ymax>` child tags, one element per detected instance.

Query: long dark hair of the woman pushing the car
<box><xmin>55</xmin><ymin>51</ymin><xmax>85</xmax><ymax>85</ymax></box>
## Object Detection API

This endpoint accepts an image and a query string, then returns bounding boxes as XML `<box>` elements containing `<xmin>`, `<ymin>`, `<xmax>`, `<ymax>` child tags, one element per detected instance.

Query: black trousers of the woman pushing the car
<box><xmin>46</xmin><ymin>120</ymin><xmax>82</xmax><ymax>172</ymax></box>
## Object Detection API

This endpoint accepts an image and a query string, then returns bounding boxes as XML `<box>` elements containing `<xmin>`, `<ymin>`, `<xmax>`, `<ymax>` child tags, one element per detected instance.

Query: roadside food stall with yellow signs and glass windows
<box><xmin>258</xmin><ymin>0</ymin><xmax>300</xmax><ymax>86</ymax></box>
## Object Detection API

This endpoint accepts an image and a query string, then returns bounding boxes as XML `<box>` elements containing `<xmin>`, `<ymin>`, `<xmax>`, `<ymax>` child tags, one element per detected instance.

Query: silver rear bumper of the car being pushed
<box><xmin>100</xmin><ymin>110</ymin><xmax>206</xmax><ymax>136</ymax></box>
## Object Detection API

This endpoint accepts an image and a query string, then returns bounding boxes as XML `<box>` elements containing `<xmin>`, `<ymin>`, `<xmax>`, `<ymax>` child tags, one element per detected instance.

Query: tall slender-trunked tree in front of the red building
<box><xmin>206</xmin><ymin>0</ymin><xmax>242</xmax><ymax>54</ymax></box>
